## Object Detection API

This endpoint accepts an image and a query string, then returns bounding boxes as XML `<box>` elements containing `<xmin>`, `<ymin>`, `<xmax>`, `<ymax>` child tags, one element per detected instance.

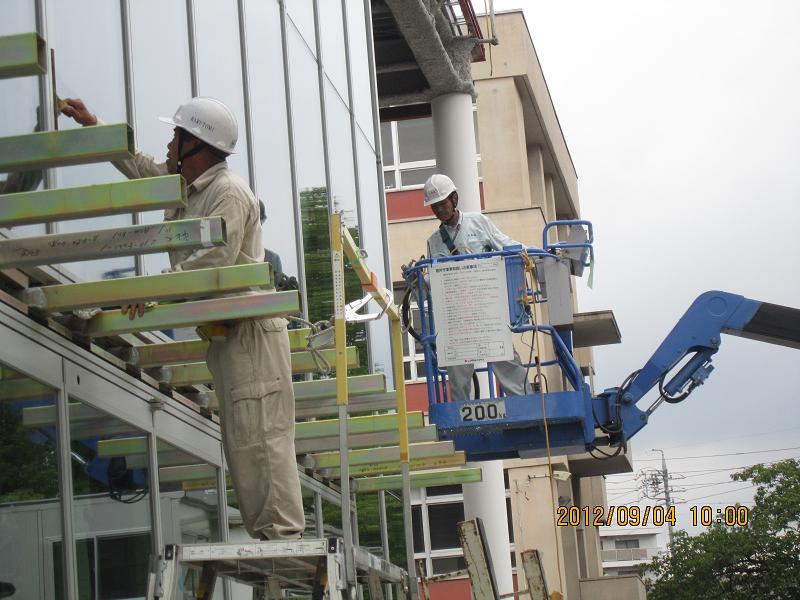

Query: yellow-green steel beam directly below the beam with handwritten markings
<box><xmin>20</xmin><ymin>263</ymin><xmax>274</xmax><ymax>312</ymax></box>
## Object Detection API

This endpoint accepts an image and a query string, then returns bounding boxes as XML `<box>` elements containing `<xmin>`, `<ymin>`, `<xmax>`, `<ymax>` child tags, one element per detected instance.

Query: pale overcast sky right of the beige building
<box><xmin>494</xmin><ymin>0</ymin><xmax>800</xmax><ymax>527</ymax></box>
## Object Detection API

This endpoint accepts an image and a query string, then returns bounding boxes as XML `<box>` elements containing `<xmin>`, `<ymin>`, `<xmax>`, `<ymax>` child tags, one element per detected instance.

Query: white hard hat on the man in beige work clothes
<box><xmin>158</xmin><ymin>96</ymin><xmax>239</xmax><ymax>154</ymax></box>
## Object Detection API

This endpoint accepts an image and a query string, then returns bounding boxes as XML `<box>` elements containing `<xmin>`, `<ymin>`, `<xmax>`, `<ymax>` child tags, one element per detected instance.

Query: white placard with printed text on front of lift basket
<box><xmin>430</xmin><ymin>256</ymin><xmax>514</xmax><ymax>367</ymax></box>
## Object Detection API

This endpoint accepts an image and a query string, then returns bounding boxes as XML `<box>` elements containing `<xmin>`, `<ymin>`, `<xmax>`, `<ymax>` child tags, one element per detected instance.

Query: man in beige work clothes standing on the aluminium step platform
<box><xmin>62</xmin><ymin>98</ymin><xmax>305</xmax><ymax>539</ymax></box>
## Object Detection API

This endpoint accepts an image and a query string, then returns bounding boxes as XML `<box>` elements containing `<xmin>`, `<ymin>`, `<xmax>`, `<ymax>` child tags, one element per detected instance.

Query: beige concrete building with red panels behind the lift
<box><xmin>381</xmin><ymin>11</ymin><xmax>638</xmax><ymax>599</ymax></box>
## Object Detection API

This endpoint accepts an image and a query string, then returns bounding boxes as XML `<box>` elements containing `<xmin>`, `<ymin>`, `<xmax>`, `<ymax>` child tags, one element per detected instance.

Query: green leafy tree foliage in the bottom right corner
<box><xmin>646</xmin><ymin>460</ymin><xmax>800</xmax><ymax>600</ymax></box>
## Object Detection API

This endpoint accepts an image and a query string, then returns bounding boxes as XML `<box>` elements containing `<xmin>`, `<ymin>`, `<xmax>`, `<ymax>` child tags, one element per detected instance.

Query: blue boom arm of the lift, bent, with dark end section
<box><xmin>592</xmin><ymin>291</ymin><xmax>800</xmax><ymax>445</ymax></box>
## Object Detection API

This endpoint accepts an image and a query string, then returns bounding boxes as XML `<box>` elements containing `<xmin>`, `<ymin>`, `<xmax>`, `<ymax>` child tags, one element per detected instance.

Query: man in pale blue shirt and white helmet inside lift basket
<box><xmin>425</xmin><ymin>173</ymin><xmax>533</xmax><ymax>401</ymax></box>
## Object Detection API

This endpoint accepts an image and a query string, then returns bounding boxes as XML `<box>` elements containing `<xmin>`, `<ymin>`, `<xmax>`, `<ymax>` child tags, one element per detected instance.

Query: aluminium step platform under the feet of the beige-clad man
<box><xmin>147</xmin><ymin>537</ymin><xmax>409</xmax><ymax>600</ymax></box>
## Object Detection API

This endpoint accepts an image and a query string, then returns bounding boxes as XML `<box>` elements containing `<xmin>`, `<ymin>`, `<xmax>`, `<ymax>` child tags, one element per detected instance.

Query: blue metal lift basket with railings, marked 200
<box><xmin>404</xmin><ymin>220</ymin><xmax>594</xmax><ymax>460</ymax></box>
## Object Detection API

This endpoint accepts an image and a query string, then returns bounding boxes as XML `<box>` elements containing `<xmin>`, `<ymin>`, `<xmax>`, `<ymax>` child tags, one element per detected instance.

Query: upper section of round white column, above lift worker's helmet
<box><xmin>431</xmin><ymin>93</ymin><xmax>481</xmax><ymax>212</ymax></box>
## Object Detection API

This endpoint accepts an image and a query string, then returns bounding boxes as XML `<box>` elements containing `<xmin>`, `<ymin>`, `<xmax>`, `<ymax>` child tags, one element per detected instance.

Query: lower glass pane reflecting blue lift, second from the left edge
<box><xmin>67</xmin><ymin>398</ymin><xmax>152</xmax><ymax>598</ymax></box>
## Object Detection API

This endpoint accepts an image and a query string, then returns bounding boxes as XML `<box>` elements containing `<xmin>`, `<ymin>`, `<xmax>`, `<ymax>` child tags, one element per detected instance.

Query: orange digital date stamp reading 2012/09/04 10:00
<box><xmin>556</xmin><ymin>505</ymin><xmax>750</xmax><ymax>527</ymax></box>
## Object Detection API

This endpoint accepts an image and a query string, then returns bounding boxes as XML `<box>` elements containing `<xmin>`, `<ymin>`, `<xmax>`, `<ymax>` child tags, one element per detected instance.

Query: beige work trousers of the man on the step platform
<box><xmin>207</xmin><ymin>319</ymin><xmax>305</xmax><ymax>540</ymax></box>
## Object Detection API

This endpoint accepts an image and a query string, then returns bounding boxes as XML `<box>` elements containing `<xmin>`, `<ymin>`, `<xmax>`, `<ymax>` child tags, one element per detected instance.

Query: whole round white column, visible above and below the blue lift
<box><xmin>431</xmin><ymin>93</ymin><xmax>514</xmax><ymax>594</ymax></box>
